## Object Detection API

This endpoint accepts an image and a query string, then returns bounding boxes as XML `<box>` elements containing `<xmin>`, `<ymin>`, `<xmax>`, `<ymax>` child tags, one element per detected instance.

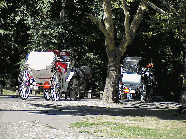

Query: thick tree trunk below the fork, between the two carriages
<box><xmin>103</xmin><ymin>50</ymin><xmax>121</xmax><ymax>103</ymax></box>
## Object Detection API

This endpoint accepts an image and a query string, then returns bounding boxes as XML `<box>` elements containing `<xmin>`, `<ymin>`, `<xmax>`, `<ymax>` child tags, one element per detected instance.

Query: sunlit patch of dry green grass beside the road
<box><xmin>70</xmin><ymin>116</ymin><xmax>186</xmax><ymax>139</ymax></box>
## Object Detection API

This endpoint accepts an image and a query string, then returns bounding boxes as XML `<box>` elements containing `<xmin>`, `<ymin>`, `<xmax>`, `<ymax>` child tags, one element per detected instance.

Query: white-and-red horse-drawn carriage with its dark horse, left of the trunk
<box><xmin>19</xmin><ymin>50</ymin><xmax>91</xmax><ymax>100</ymax></box>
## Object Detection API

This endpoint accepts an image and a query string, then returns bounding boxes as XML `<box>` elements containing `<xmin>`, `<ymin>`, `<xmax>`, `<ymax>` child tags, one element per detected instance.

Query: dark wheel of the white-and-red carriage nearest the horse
<box><xmin>68</xmin><ymin>78</ymin><xmax>81</xmax><ymax>101</ymax></box>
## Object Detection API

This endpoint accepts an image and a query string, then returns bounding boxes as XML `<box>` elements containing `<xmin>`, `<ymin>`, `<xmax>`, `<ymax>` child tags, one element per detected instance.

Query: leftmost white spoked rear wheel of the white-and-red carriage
<box><xmin>19</xmin><ymin>83</ymin><xmax>30</xmax><ymax>100</ymax></box>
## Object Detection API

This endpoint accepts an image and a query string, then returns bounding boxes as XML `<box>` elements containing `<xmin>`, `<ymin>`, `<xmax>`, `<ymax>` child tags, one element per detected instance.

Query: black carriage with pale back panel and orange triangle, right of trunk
<box><xmin>119</xmin><ymin>57</ymin><xmax>156</xmax><ymax>102</ymax></box>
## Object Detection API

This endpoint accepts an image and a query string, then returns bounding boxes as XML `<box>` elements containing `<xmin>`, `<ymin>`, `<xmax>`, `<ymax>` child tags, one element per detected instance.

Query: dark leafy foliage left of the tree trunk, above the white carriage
<box><xmin>0</xmin><ymin>0</ymin><xmax>105</xmax><ymax>88</ymax></box>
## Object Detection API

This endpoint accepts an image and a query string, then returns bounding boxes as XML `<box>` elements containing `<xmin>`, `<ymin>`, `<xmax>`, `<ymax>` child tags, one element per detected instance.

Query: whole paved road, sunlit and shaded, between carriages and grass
<box><xmin>0</xmin><ymin>96</ymin><xmax>186</xmax><ymax>138</ymax></box>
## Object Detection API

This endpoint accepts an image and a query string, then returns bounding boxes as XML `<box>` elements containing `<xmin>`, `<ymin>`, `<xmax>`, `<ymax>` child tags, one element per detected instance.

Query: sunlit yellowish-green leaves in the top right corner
<box><xmin>147</xmin><ymin>0</ymin><xmax>186</xmax><ymax>41</ymax></box>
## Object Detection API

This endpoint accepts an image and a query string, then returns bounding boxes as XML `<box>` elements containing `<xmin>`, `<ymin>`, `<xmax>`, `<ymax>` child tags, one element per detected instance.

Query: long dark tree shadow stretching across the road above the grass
<box><xmin>25</xmin><ymin>100</ymin><xmax>186</xmax><ymax>120</ymax></box>
